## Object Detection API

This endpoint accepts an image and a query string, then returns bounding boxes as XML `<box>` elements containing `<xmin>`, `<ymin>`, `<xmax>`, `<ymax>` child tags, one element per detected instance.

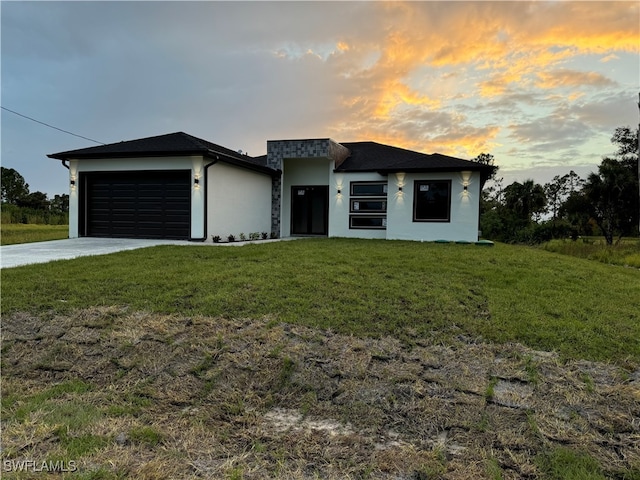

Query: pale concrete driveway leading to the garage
<box><xmin>0</xmin><ymin>237</ymin><xmax>195</xmax><ymax>268</ymax></box>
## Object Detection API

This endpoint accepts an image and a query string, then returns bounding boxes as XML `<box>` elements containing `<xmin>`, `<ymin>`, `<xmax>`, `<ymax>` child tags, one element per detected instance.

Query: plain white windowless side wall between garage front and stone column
<box><xmin>208</xmin><ymin>162</ymin><xmax>271</xmax><ymax>239</ymax></box>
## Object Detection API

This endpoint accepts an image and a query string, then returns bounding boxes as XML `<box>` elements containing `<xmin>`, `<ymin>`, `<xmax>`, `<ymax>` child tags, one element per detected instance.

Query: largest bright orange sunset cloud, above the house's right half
<box><xmin>322</xmin><ymin>2</ymin><xmax>640</xmax><ymax>157</ymax></box>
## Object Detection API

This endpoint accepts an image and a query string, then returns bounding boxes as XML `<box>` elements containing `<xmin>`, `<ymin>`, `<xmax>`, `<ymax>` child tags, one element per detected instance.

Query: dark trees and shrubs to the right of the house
<box><xmin>474</xmin><ymin>127</ymin><xmax>640</xmax><ymax>245</ymax></box>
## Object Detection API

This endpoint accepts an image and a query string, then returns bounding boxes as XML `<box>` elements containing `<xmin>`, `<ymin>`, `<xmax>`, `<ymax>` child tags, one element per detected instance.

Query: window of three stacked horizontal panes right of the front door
<box><xmin>349</xmin><ymin>182</ymin><xmax>387</xmax><ymax>230</ymax></box>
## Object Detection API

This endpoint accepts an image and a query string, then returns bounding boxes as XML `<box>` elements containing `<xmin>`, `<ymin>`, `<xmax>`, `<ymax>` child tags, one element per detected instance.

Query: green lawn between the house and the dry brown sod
<box><xmin>2</xmin><ymin>239</ymin><xmax>640</xmax><ymax>363</ymax></box>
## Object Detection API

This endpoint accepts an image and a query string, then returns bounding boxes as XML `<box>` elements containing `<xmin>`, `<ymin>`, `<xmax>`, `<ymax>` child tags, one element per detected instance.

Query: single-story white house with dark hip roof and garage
<box><xmin>48</xmin><ymin>132</ymin><xmax>492</xmax><ymax>241</ymax></box>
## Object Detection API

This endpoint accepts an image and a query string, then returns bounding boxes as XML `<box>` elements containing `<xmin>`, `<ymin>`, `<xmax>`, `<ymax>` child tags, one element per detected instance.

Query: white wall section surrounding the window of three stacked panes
<box><xmin>329</xmin><ymin>172</ymin><xmax>393</xmax><ymax>238</ymax></box>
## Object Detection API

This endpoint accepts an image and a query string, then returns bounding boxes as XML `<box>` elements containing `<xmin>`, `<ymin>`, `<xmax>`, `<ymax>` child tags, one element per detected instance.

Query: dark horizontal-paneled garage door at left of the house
<box><xmin>80</xmin><ymin>170</ymin><xmax>191</xmax><ymax>240</ymax></box>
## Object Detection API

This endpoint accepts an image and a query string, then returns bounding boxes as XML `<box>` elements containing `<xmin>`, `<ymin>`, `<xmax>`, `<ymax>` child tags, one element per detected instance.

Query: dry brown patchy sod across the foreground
<box><xmin>2</xmin><ymin>307</ymin><xmax>640</xmax><ymax>479</ymax></box>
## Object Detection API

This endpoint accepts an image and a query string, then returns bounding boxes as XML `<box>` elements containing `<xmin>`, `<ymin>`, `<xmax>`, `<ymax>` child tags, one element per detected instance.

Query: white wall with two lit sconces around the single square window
<box><xmin>387</xmin><ymin>172</ymin><xmax>480</xmax><ymax>242</ymax></box>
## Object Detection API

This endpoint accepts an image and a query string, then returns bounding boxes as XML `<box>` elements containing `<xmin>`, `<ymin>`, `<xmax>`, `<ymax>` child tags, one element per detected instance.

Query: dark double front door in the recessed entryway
<box><xmin>291</xmin><ymin>185</ymin><xmax>329</xmax><ymax>235</ymax></box>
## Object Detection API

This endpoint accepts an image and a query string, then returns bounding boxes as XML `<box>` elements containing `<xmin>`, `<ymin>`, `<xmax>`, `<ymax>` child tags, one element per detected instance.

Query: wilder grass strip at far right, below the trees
<box><xmin>542</xmin><ymin>237</ymin><xmax>640</xmax><ymax>268</ymax></box>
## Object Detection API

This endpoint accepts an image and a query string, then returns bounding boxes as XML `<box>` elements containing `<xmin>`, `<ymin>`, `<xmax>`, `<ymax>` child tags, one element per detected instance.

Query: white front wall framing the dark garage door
<box><xmin>69</xmin><ymin>156</ymin><xmax>205</xmax><ymax>238</ymax></box>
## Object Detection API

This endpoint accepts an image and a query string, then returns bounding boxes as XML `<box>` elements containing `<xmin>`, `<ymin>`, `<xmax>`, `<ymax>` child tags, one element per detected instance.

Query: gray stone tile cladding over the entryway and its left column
<box><xmin>267</xmin><ymin>138</ymin><xmax>350</xmax><ymax>234</ymax></box>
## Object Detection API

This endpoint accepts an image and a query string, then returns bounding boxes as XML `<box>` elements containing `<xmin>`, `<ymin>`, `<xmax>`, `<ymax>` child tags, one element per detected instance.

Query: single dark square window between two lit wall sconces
<box><xmin>413</xmin><ymin>180</ymin><xmax>451</xmax><ymax>222</ymax></box>
